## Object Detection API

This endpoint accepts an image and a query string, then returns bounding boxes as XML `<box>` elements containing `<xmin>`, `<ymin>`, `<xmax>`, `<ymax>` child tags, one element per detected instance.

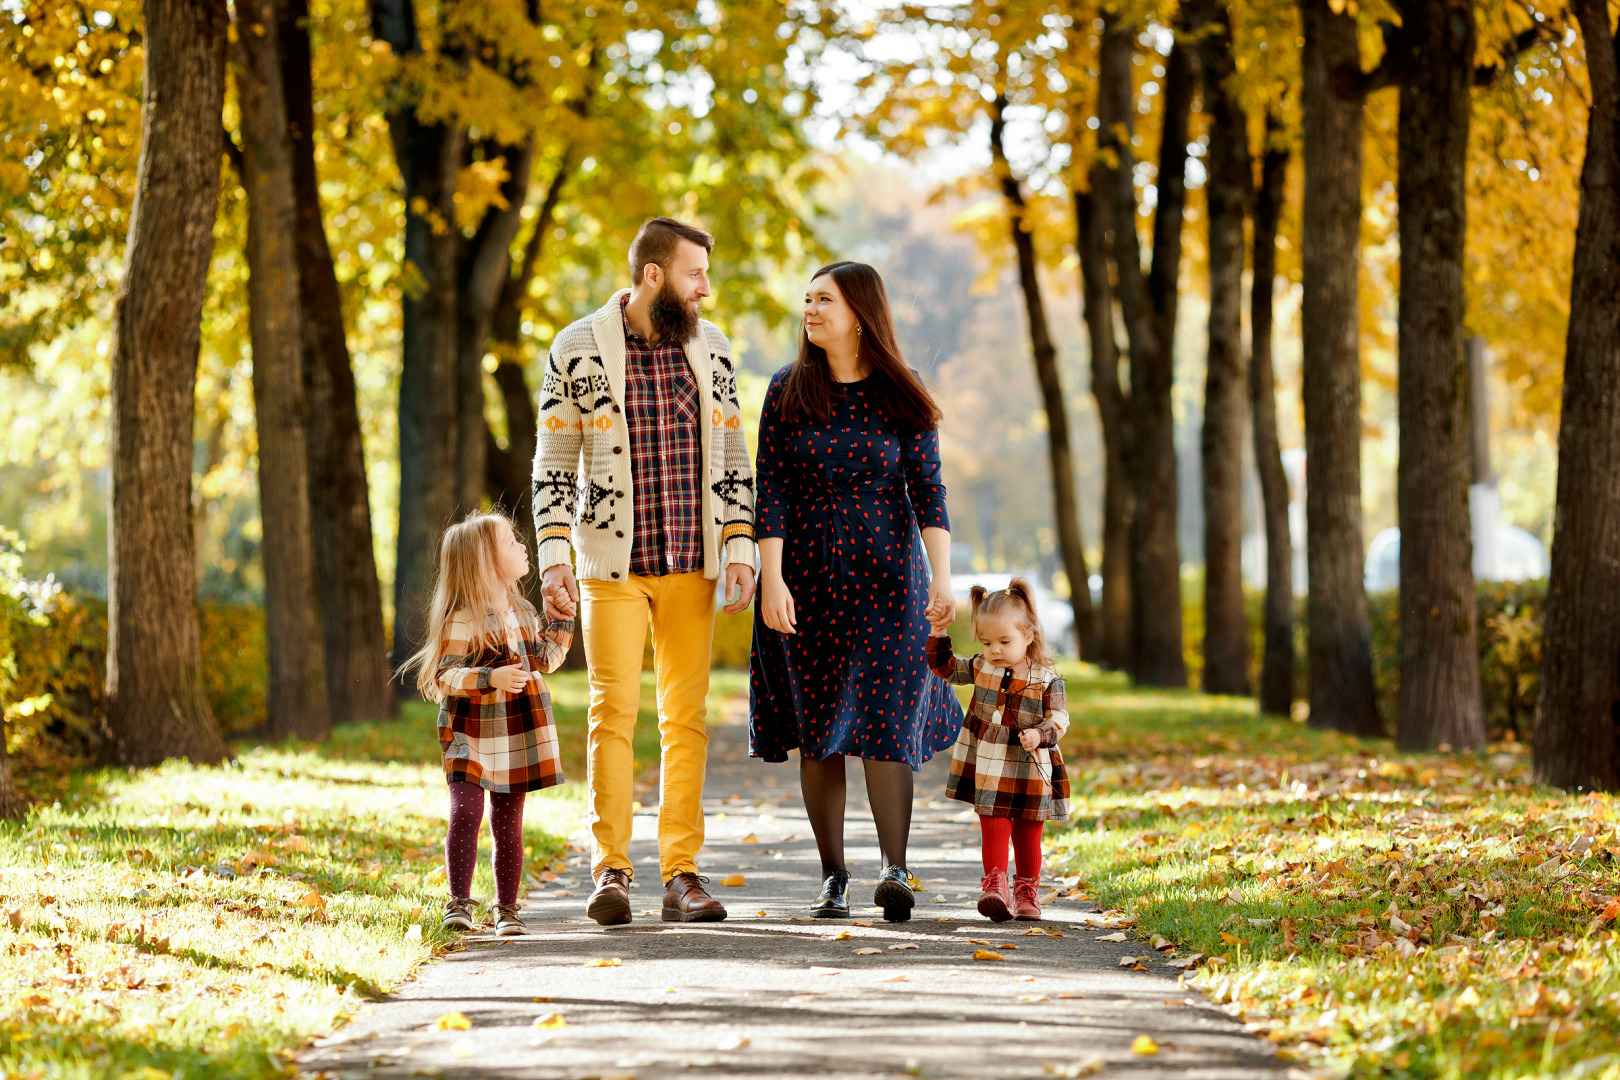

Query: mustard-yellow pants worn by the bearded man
<box><xmin>580</xmin><ymin>573</ymin><xmax>714</xmax><ymax>882</ymax></box>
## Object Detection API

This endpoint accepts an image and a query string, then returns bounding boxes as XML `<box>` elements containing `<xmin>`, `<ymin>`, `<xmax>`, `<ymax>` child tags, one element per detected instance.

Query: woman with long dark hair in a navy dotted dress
<box><xmin>748</xmin><ymin>262</ymin><xmax>962</xmax><ymax>921</ymax></box>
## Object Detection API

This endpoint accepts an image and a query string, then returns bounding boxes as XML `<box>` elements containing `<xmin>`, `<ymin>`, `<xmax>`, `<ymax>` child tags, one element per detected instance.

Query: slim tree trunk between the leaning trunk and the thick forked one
<box><xmin>1071</xmin><ymin>11</ymin><xmax>1132</xmax><ymax>670</ymax></box>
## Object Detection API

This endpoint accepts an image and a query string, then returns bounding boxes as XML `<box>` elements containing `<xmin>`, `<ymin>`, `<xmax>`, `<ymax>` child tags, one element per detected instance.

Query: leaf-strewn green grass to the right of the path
<box><xmin>1051</xmin><ymin>667</ymin><xmax>1620</xmax><ymax>1080</ymax></box>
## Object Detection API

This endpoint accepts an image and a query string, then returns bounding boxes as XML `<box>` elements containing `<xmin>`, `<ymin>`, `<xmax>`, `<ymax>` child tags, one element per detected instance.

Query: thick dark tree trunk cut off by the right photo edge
<box><xmin>1534</xmin><ymin>0</ymin><xmax>1620</xmax><ymax>792</ymax></box>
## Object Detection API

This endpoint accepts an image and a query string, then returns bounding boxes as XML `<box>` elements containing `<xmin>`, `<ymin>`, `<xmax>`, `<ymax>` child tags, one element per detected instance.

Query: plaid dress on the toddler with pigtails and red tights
<box><xmin>928</xmin><ymin>636</ymin><xmax>1069</xmax><ymax>821</ymax></box>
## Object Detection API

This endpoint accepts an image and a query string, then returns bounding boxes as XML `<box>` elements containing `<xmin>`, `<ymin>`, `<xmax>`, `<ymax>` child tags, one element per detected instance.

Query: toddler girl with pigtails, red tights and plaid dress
<box><xmin>928</xmin><ymin>578</ymin><xmax>1069</xmax><ymax>923</ymax></box>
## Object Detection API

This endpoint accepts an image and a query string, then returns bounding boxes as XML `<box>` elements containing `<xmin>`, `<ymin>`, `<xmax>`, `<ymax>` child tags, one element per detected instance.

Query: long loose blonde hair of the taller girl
<box><xmin>395</xmin><ymin>512</ymin><xmax>522</xmax><ymax>701</ymax></box>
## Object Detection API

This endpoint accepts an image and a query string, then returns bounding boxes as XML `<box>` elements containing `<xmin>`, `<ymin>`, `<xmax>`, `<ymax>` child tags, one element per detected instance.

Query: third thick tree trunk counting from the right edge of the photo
<box><xmin>1299</xmin><ymin>0</ymin><xmax>1383</xmax><ymax>735</ymax></box>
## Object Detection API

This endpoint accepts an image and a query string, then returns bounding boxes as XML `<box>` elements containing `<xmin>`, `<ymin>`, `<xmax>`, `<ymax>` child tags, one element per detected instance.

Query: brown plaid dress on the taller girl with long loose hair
<box><xmin>434</xmin><ymin>599</ymin><xmax>573</xmax><ymax>792</ymax></box>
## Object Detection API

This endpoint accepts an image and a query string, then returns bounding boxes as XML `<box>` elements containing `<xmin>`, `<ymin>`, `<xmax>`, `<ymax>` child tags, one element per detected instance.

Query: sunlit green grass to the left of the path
<box><xmin>0</xmin><ymin>672</ymin><xmax>747</xmax><ymax>1080</ymax></box>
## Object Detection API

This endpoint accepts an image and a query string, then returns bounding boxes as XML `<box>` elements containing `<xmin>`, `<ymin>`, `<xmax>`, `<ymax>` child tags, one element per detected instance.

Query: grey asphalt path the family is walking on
<box><xmin>298</xmin><ymin>696</ymin><xmax>1298</xmax><ymax>1080</ymax></box>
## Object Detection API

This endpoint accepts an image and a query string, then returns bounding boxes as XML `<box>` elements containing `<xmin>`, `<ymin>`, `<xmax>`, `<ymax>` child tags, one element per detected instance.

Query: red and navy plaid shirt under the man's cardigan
<box><xmin>619</xmin><ymin>293</ymin><xmax>703</xmax><ymax>576</ymax></box>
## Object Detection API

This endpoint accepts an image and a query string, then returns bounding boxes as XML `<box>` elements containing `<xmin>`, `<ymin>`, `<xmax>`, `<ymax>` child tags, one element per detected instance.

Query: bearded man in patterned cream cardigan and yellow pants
<box><xmin>535</xmin><ymin>217</ymin><xmax>755</xmax><ymax>926</ymax></box>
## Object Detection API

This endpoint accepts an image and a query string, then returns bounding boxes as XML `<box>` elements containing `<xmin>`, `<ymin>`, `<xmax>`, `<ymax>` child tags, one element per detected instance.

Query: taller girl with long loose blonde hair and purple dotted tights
<box><xmin>400</xmin><ymin>513</ymin><xmax>573</xmax><ymax>938</ymax></box>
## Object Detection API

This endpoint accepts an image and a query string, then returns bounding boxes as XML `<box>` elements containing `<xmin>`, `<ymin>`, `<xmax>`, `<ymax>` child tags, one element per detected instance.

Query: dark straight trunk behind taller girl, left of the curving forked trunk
<box><xmin>380</xmin><ymin>0</ymin><xmax>467</xmax><ymax>693</ymax></box>
